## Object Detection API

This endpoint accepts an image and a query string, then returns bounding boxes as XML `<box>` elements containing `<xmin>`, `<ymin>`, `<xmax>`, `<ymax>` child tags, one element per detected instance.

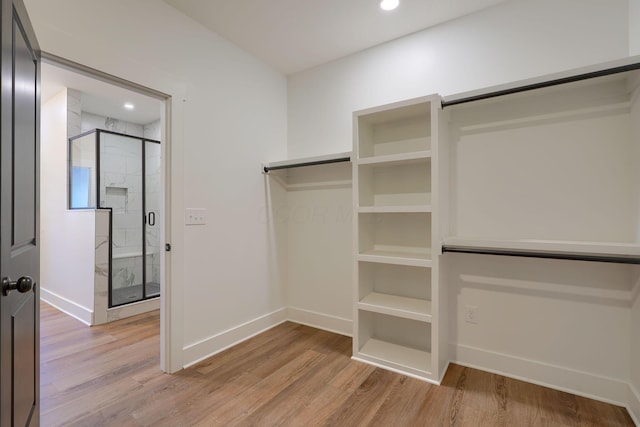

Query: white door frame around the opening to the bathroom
<box><xmin>41</xmin><ymin>51</ymin><xmax>176</xmax><ymax>373</ymax></box>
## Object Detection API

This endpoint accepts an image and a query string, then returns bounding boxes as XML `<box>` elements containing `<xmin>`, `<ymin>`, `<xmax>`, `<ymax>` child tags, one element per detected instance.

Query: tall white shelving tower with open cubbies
<box><xmin>353</xmin><ymin>96</ymin><xmax>446</xmax><ymax>382</ymax></box>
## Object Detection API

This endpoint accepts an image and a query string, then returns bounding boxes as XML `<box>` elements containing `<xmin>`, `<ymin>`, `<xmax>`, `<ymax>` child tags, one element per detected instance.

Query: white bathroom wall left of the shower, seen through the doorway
<box><xmin>40</xmin><ymin>89</ymin><xmax>95</xmax><ymax>323</ymax></box>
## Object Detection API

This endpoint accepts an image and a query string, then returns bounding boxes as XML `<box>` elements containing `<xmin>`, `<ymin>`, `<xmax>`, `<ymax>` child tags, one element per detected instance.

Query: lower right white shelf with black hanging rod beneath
<box><xmin>443</xmin><ymin>237</ymin><xmax>640</xmax><ymax>264</ymax></box>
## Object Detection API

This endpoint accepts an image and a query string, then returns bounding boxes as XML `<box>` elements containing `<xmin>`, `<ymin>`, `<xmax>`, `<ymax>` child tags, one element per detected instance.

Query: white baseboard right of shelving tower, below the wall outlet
<box><xmin>449</xmin><ymin>344</ymin><xmax>630</xmax><ymax>406</ymax></box>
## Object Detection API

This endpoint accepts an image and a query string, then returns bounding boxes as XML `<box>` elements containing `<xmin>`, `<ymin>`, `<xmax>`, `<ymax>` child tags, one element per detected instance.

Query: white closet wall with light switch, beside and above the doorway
<box><xmin>25</xmin><ymin>0</ymin><xmax>287</xmax><ymax>370</ymax></box>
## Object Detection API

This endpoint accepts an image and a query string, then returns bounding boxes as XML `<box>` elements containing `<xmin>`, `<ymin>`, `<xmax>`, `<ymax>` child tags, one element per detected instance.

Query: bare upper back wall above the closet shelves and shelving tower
<box><xmin>288</xmin><ymin>0</ymin><xmax>629</xmax><ymax>157</ymax></box>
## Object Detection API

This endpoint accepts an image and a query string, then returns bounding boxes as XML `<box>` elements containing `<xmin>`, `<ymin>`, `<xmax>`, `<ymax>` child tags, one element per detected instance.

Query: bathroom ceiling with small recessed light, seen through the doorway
<box><xmin>41</xmin><ymin>62</ymin><xmax>162</xmax><ymax>125</ymax></box>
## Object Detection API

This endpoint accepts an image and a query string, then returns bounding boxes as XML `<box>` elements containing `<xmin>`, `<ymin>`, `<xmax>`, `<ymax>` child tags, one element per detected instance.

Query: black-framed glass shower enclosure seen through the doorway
<box><xmin>69</xmin><ymin>129</ymin><xmax>161</xmax><ymax>307</ymax></box>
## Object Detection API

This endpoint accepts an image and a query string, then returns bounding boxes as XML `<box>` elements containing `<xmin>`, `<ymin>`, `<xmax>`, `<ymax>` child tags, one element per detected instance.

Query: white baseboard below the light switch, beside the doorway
<box><xmin>182</xmin><ymin>308</ymin><xmax>287</xmax><ymax>368</ymax></box>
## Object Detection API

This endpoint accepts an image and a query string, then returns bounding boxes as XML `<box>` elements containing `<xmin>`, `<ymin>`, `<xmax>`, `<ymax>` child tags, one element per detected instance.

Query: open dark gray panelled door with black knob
<box><xmin>0</xmin><ymin>0</ymin><xmax>40</xmax><ymax>427</ymax></box>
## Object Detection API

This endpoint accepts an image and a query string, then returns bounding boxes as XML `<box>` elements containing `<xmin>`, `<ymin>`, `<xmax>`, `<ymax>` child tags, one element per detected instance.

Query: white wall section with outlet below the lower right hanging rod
<box><xmin>442</xmin><ymin>254</ymin><xmax>632</xmax><ymax>403</ymax></box>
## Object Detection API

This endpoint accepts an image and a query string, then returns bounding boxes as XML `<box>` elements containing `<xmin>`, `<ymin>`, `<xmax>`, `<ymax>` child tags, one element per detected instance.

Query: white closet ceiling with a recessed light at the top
<box><xmin>164</xmin><ymin>0</ymin><xmax>506</xmax><ymax>74</ymax></box>
